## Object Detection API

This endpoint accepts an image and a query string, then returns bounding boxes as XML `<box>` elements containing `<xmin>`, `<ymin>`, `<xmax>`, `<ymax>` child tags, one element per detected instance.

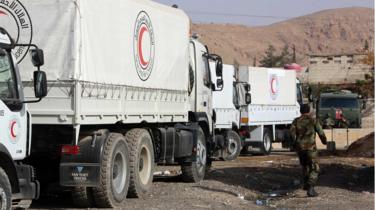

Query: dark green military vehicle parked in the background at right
<box><xmin>316</xmin><ymin>91</ymin><xmax>363</xmax><ymax>128</ymax></box>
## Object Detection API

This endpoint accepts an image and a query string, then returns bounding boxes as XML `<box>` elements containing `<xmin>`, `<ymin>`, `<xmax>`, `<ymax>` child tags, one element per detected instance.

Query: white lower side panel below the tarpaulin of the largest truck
<box><xmin>24</xmin><ymin>81</ymin><xmax>189</xmax><ymax>125</ymax></box>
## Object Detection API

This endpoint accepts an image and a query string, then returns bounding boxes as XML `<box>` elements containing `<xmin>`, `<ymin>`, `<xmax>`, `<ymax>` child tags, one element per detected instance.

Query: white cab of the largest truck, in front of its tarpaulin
<box><xmin>189</xmin><ymin>35</ymin><xmax>223</xmax><ymax>157</ymax></box>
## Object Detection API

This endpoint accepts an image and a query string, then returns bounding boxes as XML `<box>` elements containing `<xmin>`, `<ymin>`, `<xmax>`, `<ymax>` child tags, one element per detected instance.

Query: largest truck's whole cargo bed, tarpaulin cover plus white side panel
<box><xmin>15</xmin><ymin>0</ymin><xmax>190</xmax><ymax>125</ymax></box>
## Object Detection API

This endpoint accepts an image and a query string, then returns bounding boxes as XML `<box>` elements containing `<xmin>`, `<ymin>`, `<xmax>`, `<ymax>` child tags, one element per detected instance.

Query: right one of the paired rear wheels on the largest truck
<box><xmin>125</xmin><ymin>129</ymin><xmax>154</xmax><ymax>198</ymax></box>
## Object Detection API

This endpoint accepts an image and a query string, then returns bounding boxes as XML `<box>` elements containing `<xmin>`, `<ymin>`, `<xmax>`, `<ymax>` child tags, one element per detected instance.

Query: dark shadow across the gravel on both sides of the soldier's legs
<box><xmin>207</xmin><ymin>164</ymin><xmax>374</xmax><ymax>193</ymax></box>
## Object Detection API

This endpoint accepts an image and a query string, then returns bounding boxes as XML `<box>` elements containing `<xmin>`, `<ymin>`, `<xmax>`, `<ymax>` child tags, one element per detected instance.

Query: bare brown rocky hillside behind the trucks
<box><xmin>193</xmin><ymin>8</ymin><xmax>374</xmax><ymax>65</ymax></box>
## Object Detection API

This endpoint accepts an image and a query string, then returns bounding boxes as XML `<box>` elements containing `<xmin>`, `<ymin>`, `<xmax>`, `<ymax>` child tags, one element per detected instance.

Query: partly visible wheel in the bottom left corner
<box><xmin>0</xmin><ymin>168</ymin><xmax>12</xmax><ymax>210</ymax></box>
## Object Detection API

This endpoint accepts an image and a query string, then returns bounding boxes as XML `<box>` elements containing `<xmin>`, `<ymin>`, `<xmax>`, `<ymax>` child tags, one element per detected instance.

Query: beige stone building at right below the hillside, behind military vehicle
<box><xmin>307</xmin><ymin>53</ymin><xmax>373</xmax><ymax>84</ymax></box>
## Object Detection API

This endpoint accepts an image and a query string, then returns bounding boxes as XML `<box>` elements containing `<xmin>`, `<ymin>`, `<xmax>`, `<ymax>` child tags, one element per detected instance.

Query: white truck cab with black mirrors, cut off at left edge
<box><xmin>0</xmin><ymin>27</ymin><xmax>47</xmax><ymax>210</ymax></box>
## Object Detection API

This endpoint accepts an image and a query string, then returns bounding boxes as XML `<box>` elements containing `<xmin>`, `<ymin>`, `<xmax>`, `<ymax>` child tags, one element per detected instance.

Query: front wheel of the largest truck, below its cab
<box><xmin>181</xmin><ymin>128</ymin><xmax>207</xmax><ymax>183</ymax></box>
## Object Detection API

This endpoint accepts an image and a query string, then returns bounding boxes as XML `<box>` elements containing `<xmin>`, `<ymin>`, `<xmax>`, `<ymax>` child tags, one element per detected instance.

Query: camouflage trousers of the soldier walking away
<box><xmin>298</xmin><ymin>149</ymin><xmax>320</xmax><ymax>186</ymax></box>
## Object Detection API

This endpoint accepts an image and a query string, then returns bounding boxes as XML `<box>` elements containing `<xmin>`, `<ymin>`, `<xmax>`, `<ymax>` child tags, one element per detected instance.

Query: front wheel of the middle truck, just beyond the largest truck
<box><xmin>223</xmin><ymin>130</ymin><xmax>241</xmax><ymax>161</ymax></box>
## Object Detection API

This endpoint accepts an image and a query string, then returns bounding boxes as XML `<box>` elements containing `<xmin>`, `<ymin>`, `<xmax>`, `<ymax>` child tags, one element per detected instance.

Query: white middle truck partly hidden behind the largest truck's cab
<box><xmin>212</xmin><ymin>63</ymin><xmax>251</xmax><ymax>161</ymax></box>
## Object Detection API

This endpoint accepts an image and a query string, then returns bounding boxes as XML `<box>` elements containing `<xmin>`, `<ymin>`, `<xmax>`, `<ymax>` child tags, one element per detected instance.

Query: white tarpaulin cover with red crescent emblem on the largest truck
<box><xmin>5</xmin><ymin>0</ymin><xmax>190</xmax><ymax>90</ymax></box>
